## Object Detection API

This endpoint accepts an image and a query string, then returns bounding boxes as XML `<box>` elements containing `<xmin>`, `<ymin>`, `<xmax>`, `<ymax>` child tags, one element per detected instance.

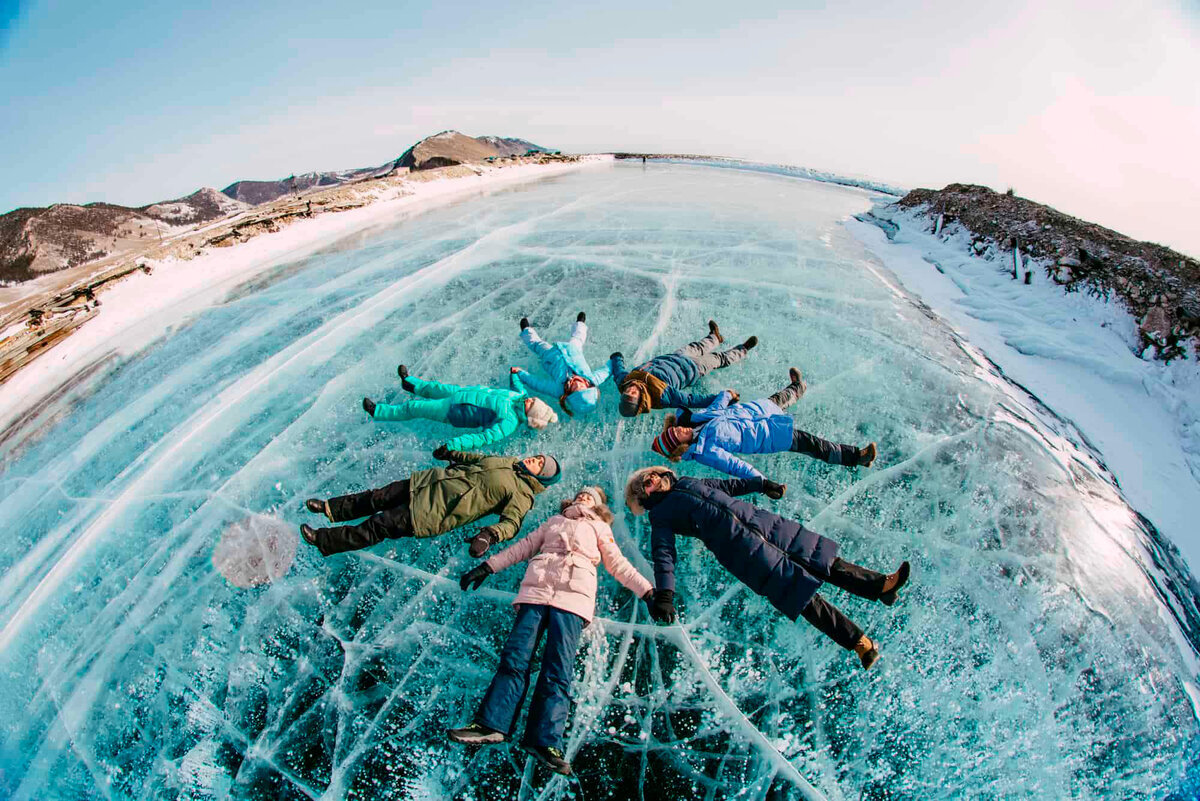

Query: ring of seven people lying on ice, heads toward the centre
<box><xmin>300</xmin><ymin>312</ymin><xmax>910</xmax><ymax>775</ymax></box>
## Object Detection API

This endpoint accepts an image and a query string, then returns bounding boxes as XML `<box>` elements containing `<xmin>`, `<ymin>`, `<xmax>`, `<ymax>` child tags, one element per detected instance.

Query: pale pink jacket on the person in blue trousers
<box><xmin>487</xmin><ymin>505</ymin><xmax>654</xmax><ymax>622</ymax></box>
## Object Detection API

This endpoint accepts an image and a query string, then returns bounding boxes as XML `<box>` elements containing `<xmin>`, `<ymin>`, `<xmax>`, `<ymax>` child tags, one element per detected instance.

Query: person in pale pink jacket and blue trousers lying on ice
<box><xmin>448</xmin><ymin>487</ymin><xmax>654</xmax><ymax>776</ymax></box>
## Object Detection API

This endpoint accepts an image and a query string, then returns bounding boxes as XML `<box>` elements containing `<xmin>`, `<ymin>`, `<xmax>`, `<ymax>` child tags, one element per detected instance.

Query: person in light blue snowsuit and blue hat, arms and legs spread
<box><xmin>512</xmin><ymin>312</ymin><xmax>612</xmax><ymax>417</ymax></box>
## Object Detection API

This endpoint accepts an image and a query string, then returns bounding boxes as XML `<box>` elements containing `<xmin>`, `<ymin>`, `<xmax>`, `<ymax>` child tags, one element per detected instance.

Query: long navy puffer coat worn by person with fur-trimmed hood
<box><xmin>646</xmin><ymin>476</ymin><xmax>838</xmax><ymax>620</ymax></box>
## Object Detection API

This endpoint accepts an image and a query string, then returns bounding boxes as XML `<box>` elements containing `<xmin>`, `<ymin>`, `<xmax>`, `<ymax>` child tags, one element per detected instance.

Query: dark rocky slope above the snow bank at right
<box><xmin>896</xmin><ymin>183</ymin><xmax>1200</xmax><ymax>359</ymax></box>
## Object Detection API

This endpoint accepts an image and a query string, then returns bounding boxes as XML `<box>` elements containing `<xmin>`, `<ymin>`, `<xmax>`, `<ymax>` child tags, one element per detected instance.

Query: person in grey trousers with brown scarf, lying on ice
<box><xmin>608</xmin><ymin>320</ymin><xmax>758</xmax><ymax>417</ymax></box>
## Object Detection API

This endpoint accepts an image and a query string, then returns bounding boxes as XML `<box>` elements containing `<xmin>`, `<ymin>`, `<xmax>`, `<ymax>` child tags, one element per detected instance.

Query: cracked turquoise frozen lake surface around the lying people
<box><xmin>0</xmin><ymin>159</ymin><xmax>1196</xmax><ymax>801</ymax></box>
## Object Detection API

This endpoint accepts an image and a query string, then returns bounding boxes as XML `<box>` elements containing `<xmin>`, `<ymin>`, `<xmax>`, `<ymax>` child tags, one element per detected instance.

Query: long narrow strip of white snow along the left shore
<box><xmin>0</xmin><ymin>156</ymin><xmax>613</xmax><ymax>430</ymax></box>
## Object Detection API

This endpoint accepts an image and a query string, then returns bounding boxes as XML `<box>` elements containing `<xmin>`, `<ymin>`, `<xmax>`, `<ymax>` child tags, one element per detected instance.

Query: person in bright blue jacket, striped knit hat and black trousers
<box><xmin>650</xmin><ymin>367</ymin><xmax>878</xmax><ymax>478</ymax></box>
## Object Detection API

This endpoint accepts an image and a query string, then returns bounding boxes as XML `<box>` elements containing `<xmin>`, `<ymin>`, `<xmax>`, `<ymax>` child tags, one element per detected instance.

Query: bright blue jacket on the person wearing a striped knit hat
<box><xmin>680</xmin><ymin>390</ymin><xmax>796</xmax><ymax>478</ymax></box>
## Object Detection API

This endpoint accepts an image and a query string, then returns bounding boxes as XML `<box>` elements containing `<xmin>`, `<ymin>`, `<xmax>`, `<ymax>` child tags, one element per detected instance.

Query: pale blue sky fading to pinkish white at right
<box><xmin>7</xmin><ymin>0</ymin><xmax>1200</xmax><ymax>254</ymax></box>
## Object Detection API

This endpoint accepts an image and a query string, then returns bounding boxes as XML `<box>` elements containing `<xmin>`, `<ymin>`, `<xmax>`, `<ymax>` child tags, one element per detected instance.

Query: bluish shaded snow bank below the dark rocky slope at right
<box><xmin>845</xmin><ymin>209</ymin><xmax>1200</xmax><ymax>582</ymax></box>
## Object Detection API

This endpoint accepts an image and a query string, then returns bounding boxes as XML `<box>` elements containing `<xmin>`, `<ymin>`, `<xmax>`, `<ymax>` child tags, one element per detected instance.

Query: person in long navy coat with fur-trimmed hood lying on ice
<box><xmin>625</xmin><ymin>466</ymin><xmax>910</xmax><ymax>668</ymax></box>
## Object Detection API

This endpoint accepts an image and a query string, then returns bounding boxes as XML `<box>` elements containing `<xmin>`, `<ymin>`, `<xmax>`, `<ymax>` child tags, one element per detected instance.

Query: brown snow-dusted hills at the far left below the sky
<box><xmin>0</xmin><ymin>188</ymin><xmax>250</xmax><ymax>282</ymax></box>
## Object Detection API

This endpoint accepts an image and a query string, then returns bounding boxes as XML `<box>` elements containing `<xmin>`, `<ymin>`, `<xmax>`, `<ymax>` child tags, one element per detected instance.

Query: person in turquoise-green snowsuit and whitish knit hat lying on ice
<box><xmin>362</xmin><ymin>365</ymin><xmax>558</xmax><ymax>451</ymax></box>
